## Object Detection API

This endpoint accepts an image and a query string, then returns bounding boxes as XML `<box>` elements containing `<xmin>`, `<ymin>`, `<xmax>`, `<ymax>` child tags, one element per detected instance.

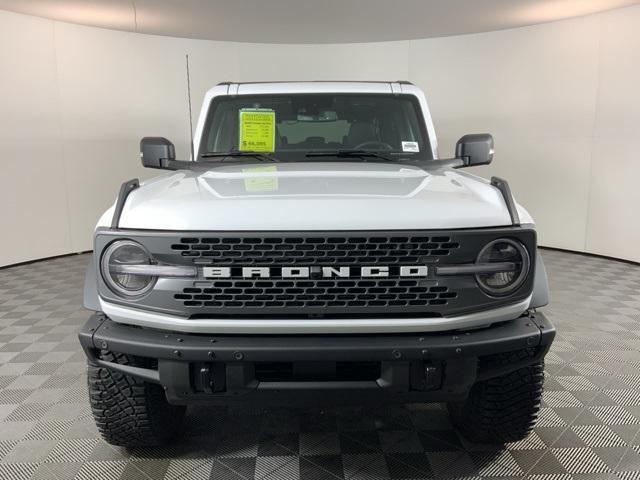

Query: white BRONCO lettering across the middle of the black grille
<box><xmin>202</xmin><ymin>265</ymin><xmax>429</xmax><ymax>278</ymax></box>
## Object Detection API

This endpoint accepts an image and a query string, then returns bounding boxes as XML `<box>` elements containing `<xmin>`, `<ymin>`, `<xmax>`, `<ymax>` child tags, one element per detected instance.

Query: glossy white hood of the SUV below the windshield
<box><xmin>111</xmin><ymin>162</ymin><xmax>531</xmax><ymax>231</ymax></box>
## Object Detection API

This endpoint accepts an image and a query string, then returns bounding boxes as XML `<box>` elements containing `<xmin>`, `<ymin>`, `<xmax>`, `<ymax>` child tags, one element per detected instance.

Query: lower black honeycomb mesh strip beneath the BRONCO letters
<box><xmin>174</xmin><ymin>278</ymin><xmax>457</xmax><ymax>309</ymax></box>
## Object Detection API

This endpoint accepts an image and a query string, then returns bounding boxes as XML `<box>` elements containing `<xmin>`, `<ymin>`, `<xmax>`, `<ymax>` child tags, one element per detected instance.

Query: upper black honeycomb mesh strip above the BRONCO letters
<box><xmin>171</xmin><ymin>235</ymin><xmax>460</xmax><ymax>266</ymax></box>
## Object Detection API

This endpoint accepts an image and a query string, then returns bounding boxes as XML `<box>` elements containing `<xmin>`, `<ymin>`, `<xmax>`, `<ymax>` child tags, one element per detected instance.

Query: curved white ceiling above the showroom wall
<box><xmin>0</xmin><ymin>0</ymin><xmax>640</xmax><ymax>43</ymax></box>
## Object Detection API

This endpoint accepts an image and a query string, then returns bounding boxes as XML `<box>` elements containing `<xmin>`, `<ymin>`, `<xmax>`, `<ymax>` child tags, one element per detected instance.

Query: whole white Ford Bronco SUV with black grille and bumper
<box><xmin>79</xmin><ymin>82</ymin><xmax>555</xmax><ymax>446</ymax></box>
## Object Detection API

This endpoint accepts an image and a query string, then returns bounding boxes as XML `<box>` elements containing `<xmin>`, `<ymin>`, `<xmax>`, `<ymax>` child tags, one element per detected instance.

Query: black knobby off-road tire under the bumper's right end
<box><xmin>447</xmin><ymin>353</ymin><xmax>544</xmax><ymax>444</ymax></box>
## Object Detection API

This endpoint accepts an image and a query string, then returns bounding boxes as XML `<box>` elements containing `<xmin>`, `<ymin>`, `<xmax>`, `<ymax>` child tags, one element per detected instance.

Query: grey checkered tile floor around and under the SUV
<box><xmin>0</xmin><ymin>250</ymin><xmax>640</xmax><ymax>480</ymax></box>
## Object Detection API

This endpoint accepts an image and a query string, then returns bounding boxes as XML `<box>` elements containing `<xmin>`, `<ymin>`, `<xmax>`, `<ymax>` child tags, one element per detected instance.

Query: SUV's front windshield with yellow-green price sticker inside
<box><xmin>199</xmin><ymin>94</ymin><xmax>432</xmax><ymax>161</ymax></box>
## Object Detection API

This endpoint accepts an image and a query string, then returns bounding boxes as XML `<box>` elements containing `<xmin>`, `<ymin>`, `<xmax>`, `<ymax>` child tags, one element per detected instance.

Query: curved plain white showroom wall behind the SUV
<box><xmin>0</xmin><ymin>6</ymin><xmax>640</xmax><ymax>266</ymax></box>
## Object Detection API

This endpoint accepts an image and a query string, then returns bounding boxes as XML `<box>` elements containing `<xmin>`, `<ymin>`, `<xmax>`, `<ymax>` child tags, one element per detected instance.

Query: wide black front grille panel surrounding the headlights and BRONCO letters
<box><xmin>95</xmin><ymin>227</ymin><xmax>535</xmax><ymax>321</ymax></box>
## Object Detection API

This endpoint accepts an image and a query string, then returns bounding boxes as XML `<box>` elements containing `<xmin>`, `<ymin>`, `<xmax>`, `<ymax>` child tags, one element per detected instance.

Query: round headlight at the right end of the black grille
<box><xmin>476</xmin><ymin>238</ymin><xmax>529</xmax><ymax>296</ymax></box>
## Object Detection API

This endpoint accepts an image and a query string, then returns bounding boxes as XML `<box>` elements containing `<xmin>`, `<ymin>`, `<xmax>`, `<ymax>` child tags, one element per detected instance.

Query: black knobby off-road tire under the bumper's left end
<box><xmin>87</xmin><ymin>351</ymin><xmax>186</xmax><ymax>447</ymax></box>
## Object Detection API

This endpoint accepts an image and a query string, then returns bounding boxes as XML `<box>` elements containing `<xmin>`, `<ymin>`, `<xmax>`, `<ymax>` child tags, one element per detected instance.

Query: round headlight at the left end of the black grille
<box><xmin>100</xmin><ymin>240</ymin><xmax>156</xmax><ymax>297</ymax></box>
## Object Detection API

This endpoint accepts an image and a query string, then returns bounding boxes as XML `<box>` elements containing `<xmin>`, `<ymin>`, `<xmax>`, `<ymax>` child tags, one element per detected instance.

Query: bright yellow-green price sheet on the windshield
<box><xmin>238</xmin><ymin>108</ymin><xmax>276</xmax><ymax>152</ymax></box>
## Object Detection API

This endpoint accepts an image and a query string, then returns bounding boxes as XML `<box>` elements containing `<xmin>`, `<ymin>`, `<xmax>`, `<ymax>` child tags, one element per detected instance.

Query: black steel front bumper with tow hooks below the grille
<box><xmin>79</xmin><ymin>313</ymin><xmax>555</xmax><ymax>404</ymax></box>
